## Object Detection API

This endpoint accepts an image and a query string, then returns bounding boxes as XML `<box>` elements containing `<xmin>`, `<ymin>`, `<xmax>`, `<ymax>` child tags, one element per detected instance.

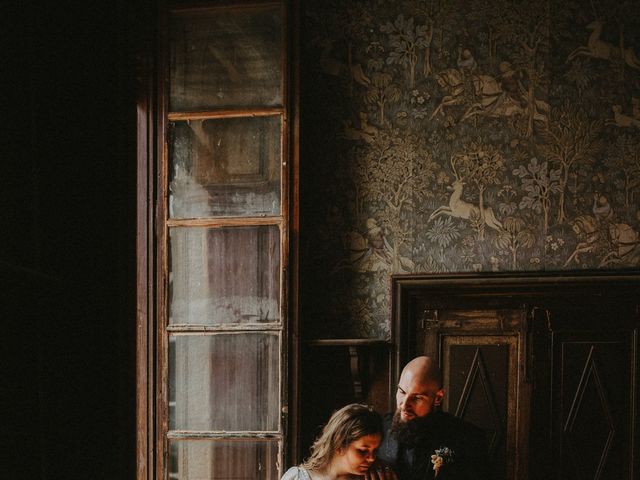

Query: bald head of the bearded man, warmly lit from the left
<box><xmin>396</xmin><ymin>356</ymin><xmax>444</xmax><ymax>422</ymax></box>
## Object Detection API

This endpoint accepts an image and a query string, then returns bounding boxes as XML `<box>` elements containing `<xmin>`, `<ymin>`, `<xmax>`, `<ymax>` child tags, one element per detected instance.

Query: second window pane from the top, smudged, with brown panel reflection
<box><xmin>169</xmin><ymin>116</ymin><xmax>281</xmax><ymax>218</ymax></box>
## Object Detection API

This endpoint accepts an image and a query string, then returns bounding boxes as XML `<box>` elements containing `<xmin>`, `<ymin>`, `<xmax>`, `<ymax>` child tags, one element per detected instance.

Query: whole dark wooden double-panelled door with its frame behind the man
<box><xmin>390</xmin><ymin>272</ymin><xmax>640</xmax><ymax>480</ymax></box>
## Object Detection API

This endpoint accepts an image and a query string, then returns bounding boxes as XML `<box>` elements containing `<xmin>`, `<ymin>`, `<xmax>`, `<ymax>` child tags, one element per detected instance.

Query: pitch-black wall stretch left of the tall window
<box><xmin>0</xmin><ymin>0</ymin><xmax>137</xmax><ymax>479</ymax></box>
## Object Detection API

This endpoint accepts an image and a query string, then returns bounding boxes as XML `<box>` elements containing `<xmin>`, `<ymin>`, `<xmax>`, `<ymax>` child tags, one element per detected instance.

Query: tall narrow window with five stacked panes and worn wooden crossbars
<box><xmin>144</xmin><ymin>1</ymin><xmax>289</xmax><ymax>480</ymax></box>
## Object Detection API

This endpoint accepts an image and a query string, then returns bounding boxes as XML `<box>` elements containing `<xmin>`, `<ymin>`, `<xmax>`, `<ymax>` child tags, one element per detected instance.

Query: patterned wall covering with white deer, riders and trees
<box><xmin>301</xmin><ymin>0</ymin><xmax>640</xmax><ymax>339</ymax></box>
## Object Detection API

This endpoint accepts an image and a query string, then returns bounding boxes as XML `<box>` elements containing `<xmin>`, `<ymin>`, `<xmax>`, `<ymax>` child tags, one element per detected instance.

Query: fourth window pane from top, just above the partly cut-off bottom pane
<box><xmin>169</xmin><ymin>332</ymin><xmax>280</xmax><ymax>431</ymax></box>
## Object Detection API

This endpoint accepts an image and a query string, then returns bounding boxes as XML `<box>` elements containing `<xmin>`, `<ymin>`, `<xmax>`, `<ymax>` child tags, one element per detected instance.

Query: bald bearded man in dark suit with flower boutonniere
<box><xmin>365</xmin><ymin>357</ymin><xmax>489</xmax><ymax>480</ymax></box>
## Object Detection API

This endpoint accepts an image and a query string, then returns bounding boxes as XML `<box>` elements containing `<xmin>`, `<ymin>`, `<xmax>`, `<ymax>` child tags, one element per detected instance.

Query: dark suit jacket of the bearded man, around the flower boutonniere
<box><xmin>378</xmin><ymin>411</ymin><xmax>491</xmax><ymax>480</ymax></box>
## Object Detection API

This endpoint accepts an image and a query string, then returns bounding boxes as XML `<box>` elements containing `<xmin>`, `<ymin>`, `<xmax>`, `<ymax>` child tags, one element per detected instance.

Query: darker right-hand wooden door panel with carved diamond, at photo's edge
<box><xmin>532</xmin><ymin>305</ymin><xmax>638</xmax><ymax>480</ymax></box>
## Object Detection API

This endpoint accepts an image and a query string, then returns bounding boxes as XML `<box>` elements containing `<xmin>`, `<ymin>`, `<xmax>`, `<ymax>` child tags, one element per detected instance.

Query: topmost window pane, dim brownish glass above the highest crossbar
<box><xmin>169</xmin><ymin>7</ymin><xmax>283</xmax><ymax>111</ymax></box>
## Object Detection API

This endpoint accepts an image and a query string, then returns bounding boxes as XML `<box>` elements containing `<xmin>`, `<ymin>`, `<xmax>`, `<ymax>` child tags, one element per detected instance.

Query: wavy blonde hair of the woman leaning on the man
<box><xmin>302</xmin><ymin>403</ymin><xmax>383</xmax><ymax>470</ymax></box>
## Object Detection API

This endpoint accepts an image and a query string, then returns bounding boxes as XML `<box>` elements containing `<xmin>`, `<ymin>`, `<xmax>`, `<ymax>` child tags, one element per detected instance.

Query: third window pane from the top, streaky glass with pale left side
<box><xmin>169</xmin><ymin>225</ymin><xmax>280</xmax><ymax>325</ymax></box>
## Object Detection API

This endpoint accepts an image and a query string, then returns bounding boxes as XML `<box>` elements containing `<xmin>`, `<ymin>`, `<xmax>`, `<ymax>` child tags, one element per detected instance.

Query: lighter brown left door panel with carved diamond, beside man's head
<box><xmin>416</xmin><ymin>308</ymin><xmax>529</xmax><ymax>480</ymax></box>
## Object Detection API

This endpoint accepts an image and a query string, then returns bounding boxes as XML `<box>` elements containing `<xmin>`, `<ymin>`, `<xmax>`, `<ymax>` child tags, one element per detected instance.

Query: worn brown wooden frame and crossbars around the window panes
<box><xmin>136</xmin><ymin>0</ymin><xmax>299</xmax><ymax>480</ymax></box>
